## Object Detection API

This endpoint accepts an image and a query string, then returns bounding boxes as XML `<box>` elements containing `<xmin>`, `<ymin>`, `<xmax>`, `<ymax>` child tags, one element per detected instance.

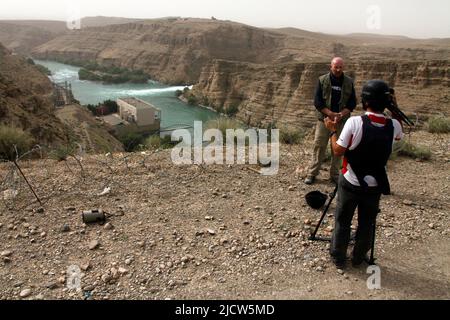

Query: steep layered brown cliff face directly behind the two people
<box><xmin>193</xmin><ymin>60</ymin><xmax>450</xmax><ymax>127</ymax></box>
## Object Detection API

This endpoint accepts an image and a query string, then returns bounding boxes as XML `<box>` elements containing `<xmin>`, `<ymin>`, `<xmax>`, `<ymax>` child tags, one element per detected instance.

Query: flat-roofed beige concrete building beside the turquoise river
<box><xmin>103</xmin><ymin>98</ymin><xmax>161</xmax><ymax>134</ymax></box>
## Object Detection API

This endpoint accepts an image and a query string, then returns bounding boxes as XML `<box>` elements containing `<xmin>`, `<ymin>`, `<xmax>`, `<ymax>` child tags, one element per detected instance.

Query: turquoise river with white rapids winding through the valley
<box><xmin>35</xmin><ymin>60</ymin><xmax>218</xmax><ymax>128</ymax></box>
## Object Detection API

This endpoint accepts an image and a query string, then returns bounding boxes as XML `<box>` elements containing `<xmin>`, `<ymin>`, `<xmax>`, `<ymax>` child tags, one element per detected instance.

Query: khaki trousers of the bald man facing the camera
<box><xmin>308</xmin><ymin>120</ymin><xmax>345</xmax><ymax>181</ymax></box>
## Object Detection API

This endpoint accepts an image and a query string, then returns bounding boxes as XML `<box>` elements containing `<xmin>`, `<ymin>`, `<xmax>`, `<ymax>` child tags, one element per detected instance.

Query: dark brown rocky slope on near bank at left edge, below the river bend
<box><xmin>0</xmin><ymin>44</ymin><xmax>122</xmax><ymax>152</ymax></box>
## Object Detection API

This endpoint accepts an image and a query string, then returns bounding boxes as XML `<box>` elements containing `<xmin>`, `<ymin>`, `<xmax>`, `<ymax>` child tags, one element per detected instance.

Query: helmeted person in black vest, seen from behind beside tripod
<box><xmin>325</xmin><ymin>80</ymin><xmax>403</xmax><ymax>269</ymax></box>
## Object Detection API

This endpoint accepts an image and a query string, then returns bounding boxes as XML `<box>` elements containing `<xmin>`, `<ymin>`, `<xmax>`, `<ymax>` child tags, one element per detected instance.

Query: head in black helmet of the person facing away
<box><xmin>361</xmin><ymin>80</ymin><xmax>391</xmax><ymax>112</ymax></box>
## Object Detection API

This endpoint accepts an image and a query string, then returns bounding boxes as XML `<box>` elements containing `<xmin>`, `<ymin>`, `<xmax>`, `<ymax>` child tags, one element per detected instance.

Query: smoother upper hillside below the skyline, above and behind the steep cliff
<box><xmin>33</xmin><ymin>18</ymin><xmax>450</xmax><ymax>84</ymax></box>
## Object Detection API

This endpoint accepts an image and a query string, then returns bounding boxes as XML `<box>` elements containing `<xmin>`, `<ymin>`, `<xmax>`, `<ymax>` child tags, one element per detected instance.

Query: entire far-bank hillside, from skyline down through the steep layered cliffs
<box><xmin>2</xmin><ymin>17</ymin><xmax>450</xmax><ymax>129</ymax></box>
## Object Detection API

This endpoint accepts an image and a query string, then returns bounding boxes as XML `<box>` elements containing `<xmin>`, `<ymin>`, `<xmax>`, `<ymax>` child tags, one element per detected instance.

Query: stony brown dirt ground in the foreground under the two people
<box><xmin>0</xmin><ymin>132</ymin><xmax>450</xmax><ymax>300</ymax></box>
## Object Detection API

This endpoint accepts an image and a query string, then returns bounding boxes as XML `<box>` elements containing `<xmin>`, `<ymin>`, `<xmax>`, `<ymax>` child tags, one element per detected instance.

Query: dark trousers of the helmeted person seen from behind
<box><xmin>330</xmin><ymin>175</ymin><xmax>381</xmax><ymax>260</ymax></box>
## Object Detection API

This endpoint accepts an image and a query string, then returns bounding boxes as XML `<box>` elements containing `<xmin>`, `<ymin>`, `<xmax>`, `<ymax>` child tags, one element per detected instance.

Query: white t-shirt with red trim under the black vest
<box><xmin>337</xmin><ymin>112</ymin><xmax>403</xmax><ymax>187</ymax></box>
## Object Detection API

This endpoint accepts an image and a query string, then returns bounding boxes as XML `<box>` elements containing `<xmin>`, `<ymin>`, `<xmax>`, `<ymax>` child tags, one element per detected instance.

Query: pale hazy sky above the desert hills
<box><xmin>0</xmin><ymin>0</ymin><xmax>450</xmax><ymax>38</ymax></box>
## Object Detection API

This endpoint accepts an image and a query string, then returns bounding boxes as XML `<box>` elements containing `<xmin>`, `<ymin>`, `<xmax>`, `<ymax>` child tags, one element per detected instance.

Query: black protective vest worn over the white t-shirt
<box><xmin>345</xmin><ymin>115</ymin><xmax>394</xmax><ymax>195</ymax></box>
